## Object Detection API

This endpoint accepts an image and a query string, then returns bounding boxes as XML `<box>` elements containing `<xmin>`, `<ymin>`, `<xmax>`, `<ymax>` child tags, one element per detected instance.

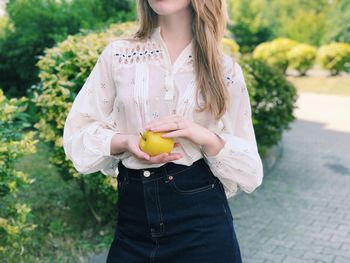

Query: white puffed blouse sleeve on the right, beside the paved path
<box><xmin>203</xmin><ymin>59</ymin><xmax>263</xmax><ymax>198</ymax></box>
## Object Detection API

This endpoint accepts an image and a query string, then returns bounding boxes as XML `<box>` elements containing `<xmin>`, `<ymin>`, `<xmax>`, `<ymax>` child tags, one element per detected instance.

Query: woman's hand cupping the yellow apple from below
<box><xmin>127</xmin><ymin>135</ymin><xmax>182</xmax><ymax>164</ymax></box>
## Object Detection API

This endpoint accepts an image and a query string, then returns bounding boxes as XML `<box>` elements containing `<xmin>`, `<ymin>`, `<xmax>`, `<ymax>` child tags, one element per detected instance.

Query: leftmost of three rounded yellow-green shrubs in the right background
<box><xmin>253</xmin><ymin>38</ymin><xmax>298</xmax><ymax>73</ymax></box>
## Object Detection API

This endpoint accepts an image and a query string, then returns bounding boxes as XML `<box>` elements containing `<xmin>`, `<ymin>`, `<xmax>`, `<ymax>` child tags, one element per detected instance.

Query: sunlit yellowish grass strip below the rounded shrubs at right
<box><xmin>287</xmin><ymin>75</ymin><xmax>350</xmax><ymax>96</ymax></box>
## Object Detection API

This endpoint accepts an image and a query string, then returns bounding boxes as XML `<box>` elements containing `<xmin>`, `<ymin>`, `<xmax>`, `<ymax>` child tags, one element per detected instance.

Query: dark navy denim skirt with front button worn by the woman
<box><xmin>107</xmin><ymin>159</ymin><xmax>242</xmax><ymax>263</ymax></box>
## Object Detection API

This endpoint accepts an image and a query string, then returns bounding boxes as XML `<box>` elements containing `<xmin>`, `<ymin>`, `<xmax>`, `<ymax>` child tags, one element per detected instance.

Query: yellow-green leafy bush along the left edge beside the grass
<box><xmin>0</xmin><ymin>89</ymin><xmax>38</xmax><ymax>262</ymax></box>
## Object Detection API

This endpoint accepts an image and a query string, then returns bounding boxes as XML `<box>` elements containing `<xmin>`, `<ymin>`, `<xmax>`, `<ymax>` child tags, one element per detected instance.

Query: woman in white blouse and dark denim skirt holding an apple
<box><xmin>63</xmin><ymin>0</ymin><xmax>263</xmax><ymax>263</ymax></box>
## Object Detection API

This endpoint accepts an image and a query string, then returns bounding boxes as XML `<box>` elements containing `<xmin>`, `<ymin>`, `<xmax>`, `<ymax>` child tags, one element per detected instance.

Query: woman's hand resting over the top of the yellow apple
<box><xmin>145</xmin><ymin>115</ymin><xmax>224</xmax><ymax>155</ymax></box>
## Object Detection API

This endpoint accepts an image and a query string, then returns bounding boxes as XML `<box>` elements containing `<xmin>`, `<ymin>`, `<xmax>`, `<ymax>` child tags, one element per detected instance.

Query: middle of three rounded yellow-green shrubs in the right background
<box><xmin>288</xmin><ymin>44</ymin><xmax>317</xmax><ymax>76</ymax></box>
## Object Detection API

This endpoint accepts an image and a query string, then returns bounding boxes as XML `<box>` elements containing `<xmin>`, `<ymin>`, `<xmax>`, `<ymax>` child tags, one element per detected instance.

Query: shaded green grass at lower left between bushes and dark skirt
<box><xmin>10</xmin><ymin>140</ymin><xmax>114</xmax><ymax>263</ymax></box>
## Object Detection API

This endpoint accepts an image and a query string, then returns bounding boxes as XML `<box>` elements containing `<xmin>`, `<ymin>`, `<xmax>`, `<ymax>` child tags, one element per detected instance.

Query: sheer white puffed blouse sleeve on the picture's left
<box><xmin>63</xmin><ymin>43</ymin><xmax>123</xmax><ymax>174</ymax></box>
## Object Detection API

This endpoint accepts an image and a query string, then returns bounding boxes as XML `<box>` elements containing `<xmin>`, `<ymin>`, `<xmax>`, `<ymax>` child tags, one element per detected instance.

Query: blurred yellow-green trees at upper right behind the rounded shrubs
<box><xmin>228</xmin><ymin>0</ymin><xmax>350</xmax><ymax>52</ymax></box>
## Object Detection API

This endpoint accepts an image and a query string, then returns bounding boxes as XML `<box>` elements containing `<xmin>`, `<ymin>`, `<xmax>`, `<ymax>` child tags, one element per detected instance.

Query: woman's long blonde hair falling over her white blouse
<box><xmin>135</xmin><ymin>0</ymin><xmax>229</xmax><ymax>120</ymax></box>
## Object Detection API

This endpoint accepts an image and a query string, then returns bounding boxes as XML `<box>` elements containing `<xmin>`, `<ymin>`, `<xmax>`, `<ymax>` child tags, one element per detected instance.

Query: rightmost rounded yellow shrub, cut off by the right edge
<box><xmin>317</xmin><ymin>43</ymin><xmax>350</xmax><ymax>76</ymax></box>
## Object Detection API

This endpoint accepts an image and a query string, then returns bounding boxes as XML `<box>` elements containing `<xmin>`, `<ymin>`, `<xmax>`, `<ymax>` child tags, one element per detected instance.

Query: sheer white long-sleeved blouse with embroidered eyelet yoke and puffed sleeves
<box><xmin>63</xmin><ymin>27</ymin><xmax>263</xmax><ymax>198</ymax></box>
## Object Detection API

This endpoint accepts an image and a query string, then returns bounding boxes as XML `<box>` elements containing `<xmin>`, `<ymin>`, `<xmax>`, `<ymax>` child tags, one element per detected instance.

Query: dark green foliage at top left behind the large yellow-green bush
<box><xmin>0</xmin><ymin>0</ymin><xmax>134</xmax><ymax>97</ymax></box>
